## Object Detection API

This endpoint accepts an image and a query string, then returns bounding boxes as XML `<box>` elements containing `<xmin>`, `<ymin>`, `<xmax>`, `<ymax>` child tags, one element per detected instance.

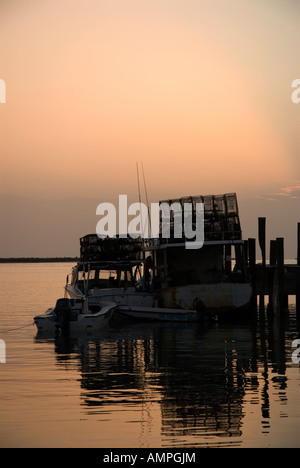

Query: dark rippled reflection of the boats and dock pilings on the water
<box><xmin>36</xmin><ymin>310</ymin><xmax>300</xmax><ymax>446</ymax></box>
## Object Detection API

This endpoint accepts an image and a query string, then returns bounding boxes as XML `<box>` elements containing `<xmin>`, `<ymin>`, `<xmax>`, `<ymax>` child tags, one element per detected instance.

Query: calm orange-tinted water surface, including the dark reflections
<box><xmin>0</xmin><ymin>263</ymin><xmax>300</xmax><ymax>448</ymax></box>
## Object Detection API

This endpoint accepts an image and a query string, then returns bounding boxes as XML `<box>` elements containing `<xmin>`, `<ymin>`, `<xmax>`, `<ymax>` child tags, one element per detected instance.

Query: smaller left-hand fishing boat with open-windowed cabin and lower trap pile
<box><xmin>65</xmin><ymin>234</ymin><xmax>156</xmax><ymax>307</ymax></box>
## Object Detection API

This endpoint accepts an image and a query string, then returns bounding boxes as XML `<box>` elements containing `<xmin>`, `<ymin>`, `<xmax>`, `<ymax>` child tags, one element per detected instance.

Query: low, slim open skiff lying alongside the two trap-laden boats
<box><xmin>116</xmin><ymin>306</ymin><xmax>203</xmax><ymax>322</ymax></box>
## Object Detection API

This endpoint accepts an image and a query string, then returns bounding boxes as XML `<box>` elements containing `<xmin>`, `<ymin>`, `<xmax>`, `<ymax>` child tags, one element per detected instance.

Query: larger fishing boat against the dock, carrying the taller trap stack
<box><xmin>145</xmin><ymin>193</ymin><xmax>252</xmax><ymax>316</ymax></box>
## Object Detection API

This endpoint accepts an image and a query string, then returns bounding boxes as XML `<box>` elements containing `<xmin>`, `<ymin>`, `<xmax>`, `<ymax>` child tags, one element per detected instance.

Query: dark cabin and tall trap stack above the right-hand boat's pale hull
<box><xmin>146</xmin><ymin>193</ymin><xmax>246</xmax><ymax>289</ymax></box>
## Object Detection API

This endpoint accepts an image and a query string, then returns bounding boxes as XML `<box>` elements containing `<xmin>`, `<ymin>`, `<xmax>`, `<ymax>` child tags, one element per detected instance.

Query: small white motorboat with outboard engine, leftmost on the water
<box><xmin>34</xmin><ymin>298</ymin><xmax>116</xmax><ymax>333</ymax></box>
